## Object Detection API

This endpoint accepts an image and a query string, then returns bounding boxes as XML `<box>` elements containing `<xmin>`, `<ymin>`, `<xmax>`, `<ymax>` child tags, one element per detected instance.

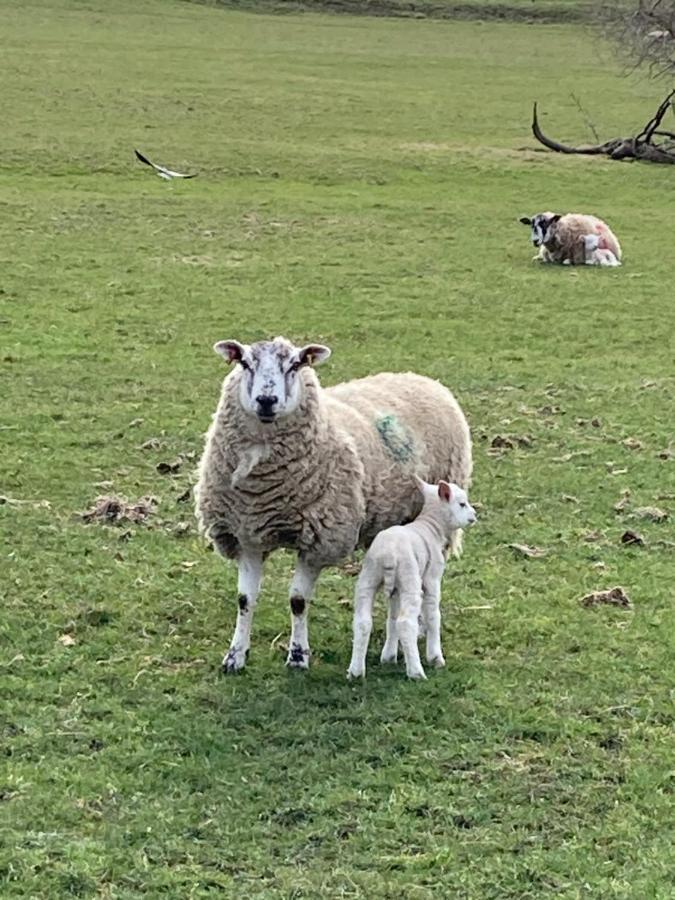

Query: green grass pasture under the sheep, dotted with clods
<box><xmin>0</xmin><ymin>0</ymin><xmax>675</xmax><ymax>900</ymax></box>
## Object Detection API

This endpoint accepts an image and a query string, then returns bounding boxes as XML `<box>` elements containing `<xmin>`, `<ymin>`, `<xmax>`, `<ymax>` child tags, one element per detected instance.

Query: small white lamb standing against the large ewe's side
<box><xmin>347</xmin><ymin>479</ymin><xmax>476</xmax><ymax>678</ymax></box>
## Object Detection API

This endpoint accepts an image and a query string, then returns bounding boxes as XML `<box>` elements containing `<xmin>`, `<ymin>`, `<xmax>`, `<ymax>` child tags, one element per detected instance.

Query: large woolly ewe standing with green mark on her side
<box><xmin>196</xmin><ymin>337</ymin><xmax>471</xmax><ymax>672</ymax></box>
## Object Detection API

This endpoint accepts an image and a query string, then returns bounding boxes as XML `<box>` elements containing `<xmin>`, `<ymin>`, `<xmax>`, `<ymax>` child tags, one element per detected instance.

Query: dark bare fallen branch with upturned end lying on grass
<box><xmin>532</xmin><ymin>90</ymin><xmax>675</xmax><ymax>164</ymax></box>
